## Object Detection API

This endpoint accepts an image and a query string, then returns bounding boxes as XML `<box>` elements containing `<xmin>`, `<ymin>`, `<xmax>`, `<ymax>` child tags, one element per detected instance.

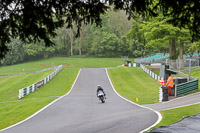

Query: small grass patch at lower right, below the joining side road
<box><xmin>154</xmin><ymin>104</ymin><xmax>200</xmax><ymax>128</ymax></box>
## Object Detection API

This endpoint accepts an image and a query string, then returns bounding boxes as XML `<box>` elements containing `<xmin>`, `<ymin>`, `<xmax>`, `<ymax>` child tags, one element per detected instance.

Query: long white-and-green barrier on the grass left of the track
<box><xmin>19</xmin><ymin>65</ymin><xmax>62</xmax><ymax>99</ymax></box>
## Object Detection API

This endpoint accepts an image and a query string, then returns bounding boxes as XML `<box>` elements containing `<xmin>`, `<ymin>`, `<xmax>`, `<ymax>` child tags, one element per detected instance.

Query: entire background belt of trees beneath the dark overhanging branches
<box><xmin>1</xmin><ymin>11</ymin><xmax>199</xmax><ymax>65</ymax></box>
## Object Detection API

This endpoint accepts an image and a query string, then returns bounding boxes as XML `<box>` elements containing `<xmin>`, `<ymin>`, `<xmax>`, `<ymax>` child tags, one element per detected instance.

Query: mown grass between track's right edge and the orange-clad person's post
<box><xmin>108</xmin><ymin>68</ymin><xmax>160</xmax><ymax>104</ymax></box>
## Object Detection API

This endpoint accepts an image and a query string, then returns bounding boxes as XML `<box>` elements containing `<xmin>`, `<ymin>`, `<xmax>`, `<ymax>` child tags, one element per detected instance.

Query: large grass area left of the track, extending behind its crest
<box><xmin>0</xmin><ymin>57</ymin><xmax>122</xmax><ymax>129</ymax></box>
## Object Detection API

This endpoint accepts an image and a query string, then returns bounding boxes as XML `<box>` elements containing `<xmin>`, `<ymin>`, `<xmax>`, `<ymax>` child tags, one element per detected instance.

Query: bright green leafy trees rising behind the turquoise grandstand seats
<box><xmin>127</xmin><ymin>14</ymin><xmax>196</xmax><ymax>59</ymax></box>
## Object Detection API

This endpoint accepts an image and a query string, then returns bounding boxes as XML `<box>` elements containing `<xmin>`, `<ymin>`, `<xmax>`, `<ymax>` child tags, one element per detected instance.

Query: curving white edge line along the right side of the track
<box><xmin>105</xmin><ymin>68</ymin><xmax>162</xmax><ymax>133</ymax></box>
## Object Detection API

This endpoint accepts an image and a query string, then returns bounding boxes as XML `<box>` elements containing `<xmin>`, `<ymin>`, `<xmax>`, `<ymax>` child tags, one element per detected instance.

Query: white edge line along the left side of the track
<box><xmin>0</xmin><ymin>69</ymin><xmax>81</xmax><ymax>132</ymax></box>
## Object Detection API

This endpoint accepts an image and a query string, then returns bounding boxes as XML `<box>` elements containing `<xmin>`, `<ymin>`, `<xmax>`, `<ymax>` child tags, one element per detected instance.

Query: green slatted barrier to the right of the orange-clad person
<box><xmin>175</xmin><ymin>79</ymin><xmax>199</xmax><ymax>97</ymax></box>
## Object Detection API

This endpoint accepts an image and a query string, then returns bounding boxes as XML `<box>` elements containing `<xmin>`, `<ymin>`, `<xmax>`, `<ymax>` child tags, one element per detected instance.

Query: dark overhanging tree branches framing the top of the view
<box><xmin>0</xmin><ymin>0</ymin><xmax>200</xmax><ymax>58</ymax></box>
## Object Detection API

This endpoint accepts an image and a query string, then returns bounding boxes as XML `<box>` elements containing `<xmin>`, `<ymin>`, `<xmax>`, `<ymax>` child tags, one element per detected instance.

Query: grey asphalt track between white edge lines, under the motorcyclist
<box><xmin>2</xmin><ymin>68</ymin><xmax>159</xmax><ymax>133</ymax></box>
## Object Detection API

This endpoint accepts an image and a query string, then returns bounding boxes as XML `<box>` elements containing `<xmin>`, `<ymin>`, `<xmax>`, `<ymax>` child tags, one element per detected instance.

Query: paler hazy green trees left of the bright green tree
<box><xmin>2</xmin><ymin>11</ymin><xmax>131</xmax><ymax>65</ymax></box>
